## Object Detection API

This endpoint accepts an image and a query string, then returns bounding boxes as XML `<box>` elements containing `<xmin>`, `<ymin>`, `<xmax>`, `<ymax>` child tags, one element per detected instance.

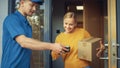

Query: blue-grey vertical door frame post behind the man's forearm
<box><xmin>44</xmin><ymin>0</ymin><xmax>52</xmax><ymax>68</ymax></box>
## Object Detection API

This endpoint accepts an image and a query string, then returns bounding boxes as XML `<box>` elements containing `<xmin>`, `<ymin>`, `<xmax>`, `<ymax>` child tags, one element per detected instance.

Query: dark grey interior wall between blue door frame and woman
<box><xmin>52</xmin><ymin>0</ymin><xmax>65</xmax><ymax>68</ymax></box>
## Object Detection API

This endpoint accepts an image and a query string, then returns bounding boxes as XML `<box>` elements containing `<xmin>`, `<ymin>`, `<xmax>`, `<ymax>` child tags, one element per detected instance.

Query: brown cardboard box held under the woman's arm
<box><xmin>78</xmin><ymin>37</ymin><xmax>101</xmax><ymax>62</ymax></box>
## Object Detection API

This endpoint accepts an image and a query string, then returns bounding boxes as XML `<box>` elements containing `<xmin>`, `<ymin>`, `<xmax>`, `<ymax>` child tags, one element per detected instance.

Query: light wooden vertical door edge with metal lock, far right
<box><xmin>108</xmin><ymin>0</ymin><xmax>117</xmax><ymax>68</ymax></box>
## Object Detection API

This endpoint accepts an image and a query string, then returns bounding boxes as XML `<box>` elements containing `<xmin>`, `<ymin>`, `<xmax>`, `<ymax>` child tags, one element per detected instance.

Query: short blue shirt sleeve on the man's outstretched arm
<box><xmin>4</xmin><ymin>16</ymin><xmax>25</xmax><ymax>39</ymax></box>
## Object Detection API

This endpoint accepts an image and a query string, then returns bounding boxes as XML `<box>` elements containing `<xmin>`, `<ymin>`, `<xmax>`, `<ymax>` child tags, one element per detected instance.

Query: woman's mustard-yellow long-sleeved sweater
<box><xmin>52</xmin><ymin>28</ymin><xmax>90</xmax><ymax>68</ymax></box>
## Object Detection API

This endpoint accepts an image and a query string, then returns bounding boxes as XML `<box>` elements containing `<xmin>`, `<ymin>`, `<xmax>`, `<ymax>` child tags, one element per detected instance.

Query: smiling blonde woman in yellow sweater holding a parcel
<box><xmin>52</xmin><ymin>12</ymin><xmax>104</xmax><ymax>68</ymax></box>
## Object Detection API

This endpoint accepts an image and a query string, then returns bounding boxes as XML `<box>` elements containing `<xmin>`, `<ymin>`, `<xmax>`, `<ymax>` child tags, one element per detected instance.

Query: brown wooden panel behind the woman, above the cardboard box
<box><xmin>83</xmin><ymin>0</ymin><xmax>104</xmax><ymax>68</ymax></box>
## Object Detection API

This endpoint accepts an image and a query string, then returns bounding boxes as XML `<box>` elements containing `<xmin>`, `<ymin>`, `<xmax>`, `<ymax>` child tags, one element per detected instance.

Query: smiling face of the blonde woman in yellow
<box><xmin>63</xmin><ymin>18</ymin><xmax>76</xmax><ymax>33</ymax></box>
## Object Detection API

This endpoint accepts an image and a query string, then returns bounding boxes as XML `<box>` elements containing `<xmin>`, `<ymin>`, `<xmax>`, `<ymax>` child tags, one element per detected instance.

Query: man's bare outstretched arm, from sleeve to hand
<box><xmin>15</xmin><ymin>35</ymin><xmax>64</xmax><ymax>53</ymax></box>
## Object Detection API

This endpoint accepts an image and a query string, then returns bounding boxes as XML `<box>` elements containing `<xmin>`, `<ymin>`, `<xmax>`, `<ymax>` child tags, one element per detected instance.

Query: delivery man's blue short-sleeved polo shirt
<box><xmin>1</xmin><ymin>11</ymin><xmax>32</xmax><ymax>68</ymax></box>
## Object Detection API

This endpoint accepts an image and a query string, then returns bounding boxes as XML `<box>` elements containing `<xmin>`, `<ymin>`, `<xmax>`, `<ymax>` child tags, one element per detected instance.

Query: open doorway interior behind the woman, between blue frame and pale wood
<box><xmin>52</xmin><ymin>0</ymin><xmax>108</xmax><ymax>68</ymax></box>
